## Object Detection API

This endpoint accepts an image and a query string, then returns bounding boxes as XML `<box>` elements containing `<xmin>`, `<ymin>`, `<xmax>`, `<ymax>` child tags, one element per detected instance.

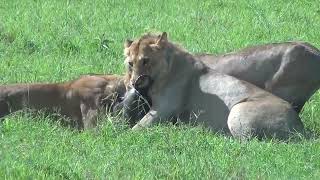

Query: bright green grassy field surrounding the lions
<box><xmin>0</xmin><ymin>0</ymin><xmax>320</xmax><ymax>179</ymax></box>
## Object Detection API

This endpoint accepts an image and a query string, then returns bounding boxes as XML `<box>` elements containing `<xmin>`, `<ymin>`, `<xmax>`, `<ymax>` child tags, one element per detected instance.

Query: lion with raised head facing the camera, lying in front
<box><xmin>125</xmin><ymin>33</ymin><xmax>303</xmax><ymax>138</ymax></box>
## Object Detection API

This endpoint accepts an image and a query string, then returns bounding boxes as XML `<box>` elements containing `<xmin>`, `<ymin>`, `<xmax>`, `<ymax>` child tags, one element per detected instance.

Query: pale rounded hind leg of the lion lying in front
<box><xmin>228</xmin><ymin>99</ymin><xmax>304</xmax><ymax>139</ymax></box>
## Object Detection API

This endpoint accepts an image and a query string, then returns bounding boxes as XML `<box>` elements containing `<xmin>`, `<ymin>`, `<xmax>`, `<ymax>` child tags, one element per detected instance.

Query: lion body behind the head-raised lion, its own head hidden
<box><xmin>125</xmin><ymin>40</ymin><xmax>320</xmax><ymax>113</ymax></box>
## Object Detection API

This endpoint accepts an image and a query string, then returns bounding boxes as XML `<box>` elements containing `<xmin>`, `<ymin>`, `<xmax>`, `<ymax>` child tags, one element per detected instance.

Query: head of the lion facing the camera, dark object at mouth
<box><xmin>124</xmin><ymin>32</ymin><xmax>169</xmax><ymax>88</ymax></box>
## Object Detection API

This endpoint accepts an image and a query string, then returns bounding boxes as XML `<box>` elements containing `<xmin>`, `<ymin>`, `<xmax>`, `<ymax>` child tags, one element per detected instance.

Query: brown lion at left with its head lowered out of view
<box><xmin>0</xmin><ymin>75</ymin><xmax>126</xmax><ymax>130</ymax></box>
